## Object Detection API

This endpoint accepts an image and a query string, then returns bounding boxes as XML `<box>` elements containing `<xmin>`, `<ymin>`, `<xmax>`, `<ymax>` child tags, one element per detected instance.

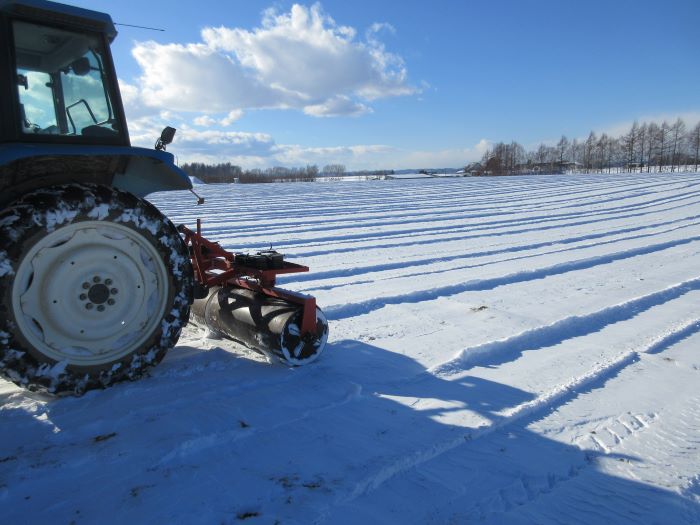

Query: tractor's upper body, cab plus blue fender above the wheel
<box><xmin>0</xmin><ymin>0</ymin><xmax>192</xmax><ymax>209</ymax></box>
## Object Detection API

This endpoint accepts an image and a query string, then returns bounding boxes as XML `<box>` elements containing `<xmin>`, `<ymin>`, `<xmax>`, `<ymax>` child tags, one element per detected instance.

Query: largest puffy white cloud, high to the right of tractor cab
<box><xmin>125</xmin><ymin>4</ymin><xmax>416</xmax><ymax>119</ymax></box>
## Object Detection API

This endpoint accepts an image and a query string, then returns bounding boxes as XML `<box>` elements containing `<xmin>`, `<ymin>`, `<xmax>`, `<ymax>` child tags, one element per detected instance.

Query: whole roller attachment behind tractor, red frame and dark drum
<box><xmin>179</xmin><ymin>220</ymin><xmax>328</xmax><ymax>366</ymax></box>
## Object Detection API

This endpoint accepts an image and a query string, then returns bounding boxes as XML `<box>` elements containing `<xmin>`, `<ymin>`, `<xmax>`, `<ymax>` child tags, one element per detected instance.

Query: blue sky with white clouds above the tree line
<box><xmin>69</xmin><ymin>0</ymin><xmax>700</xmax><ymax>169</ymax></box>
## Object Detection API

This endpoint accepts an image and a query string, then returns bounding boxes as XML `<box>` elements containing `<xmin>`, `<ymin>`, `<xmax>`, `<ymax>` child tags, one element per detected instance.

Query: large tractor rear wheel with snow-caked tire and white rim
<box><xmin>0</xmin><ymin>184</ymin><xmax>193</xmax><ymax>394</ymax></box>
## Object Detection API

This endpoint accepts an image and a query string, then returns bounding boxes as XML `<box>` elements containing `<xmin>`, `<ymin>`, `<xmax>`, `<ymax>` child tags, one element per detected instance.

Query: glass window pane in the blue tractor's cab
<box><xmin>13</xmin><ymin>22</ymin><xmax>120</xmax><ymax>138</ymax></box>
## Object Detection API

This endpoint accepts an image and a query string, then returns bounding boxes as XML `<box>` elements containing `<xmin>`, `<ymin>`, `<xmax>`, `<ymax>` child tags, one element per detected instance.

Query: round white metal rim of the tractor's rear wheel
<box><xmin>12</xmin><ymin>221</ymin><xmax>169</xmax><ymax>366</ymax></box>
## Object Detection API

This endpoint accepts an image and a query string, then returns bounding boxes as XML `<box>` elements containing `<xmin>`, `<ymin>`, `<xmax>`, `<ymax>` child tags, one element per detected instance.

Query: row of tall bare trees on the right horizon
<box><xmin>464</xmin><ymin>118</ymin><xmax>700</xmax><ymax>175</ymax></box>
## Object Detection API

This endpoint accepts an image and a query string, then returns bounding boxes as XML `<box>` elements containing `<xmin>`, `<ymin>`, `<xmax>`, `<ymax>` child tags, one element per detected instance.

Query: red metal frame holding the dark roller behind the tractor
<box><xmin>178</xmin><ymin>219</ymin><xmax>316</xmax><ymax>336</ymax></box>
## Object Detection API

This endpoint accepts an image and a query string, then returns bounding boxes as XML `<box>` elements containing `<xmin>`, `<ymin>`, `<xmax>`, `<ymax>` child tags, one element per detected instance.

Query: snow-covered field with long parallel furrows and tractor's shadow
<box><xmin>0</xmin><ymin>174</ymin><xmax>700</xmax><ymax>525</ymax></box>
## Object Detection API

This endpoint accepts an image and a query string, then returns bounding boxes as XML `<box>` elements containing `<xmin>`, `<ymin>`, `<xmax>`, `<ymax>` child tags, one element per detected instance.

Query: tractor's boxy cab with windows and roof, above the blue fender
<box><xmin>0</xmin><ymin>0</ymin><xmax>129</xmax><ymax>145</ymax></box>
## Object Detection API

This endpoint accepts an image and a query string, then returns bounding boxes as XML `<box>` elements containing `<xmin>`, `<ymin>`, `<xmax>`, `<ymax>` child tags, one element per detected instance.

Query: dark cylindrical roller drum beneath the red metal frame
<box><xmin>190</xmin><ymin>286</ymin><xmax>328</xmax><ymax>366</ymax></box>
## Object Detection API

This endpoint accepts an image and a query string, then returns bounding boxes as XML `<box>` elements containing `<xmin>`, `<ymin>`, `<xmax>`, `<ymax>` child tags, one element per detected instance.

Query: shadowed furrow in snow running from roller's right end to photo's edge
<box><xmin>322</xmin><ymin>236</ymin><xmax>700</xmax><ymax>321</ymax></box>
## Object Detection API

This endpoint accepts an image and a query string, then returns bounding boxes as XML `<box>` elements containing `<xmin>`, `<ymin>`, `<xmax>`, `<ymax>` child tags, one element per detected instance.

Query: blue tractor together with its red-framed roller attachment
<box><xmin>0</xmin><ymin>0</ymin><xmax>328</xmax><ymax>394</ymax></box>
